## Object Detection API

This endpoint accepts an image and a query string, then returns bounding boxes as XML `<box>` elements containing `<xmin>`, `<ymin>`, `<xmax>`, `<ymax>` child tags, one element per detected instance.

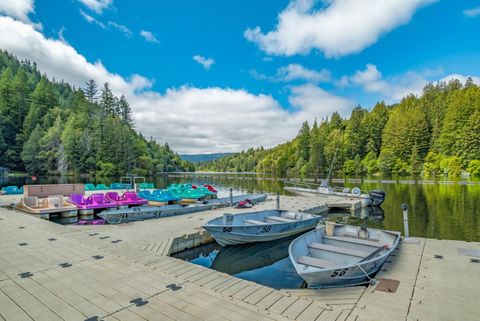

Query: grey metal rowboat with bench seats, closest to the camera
<box><xmin>288</xmin><ymin>222</ymin><xmax>400</xmax><ymax>288</ymax></box>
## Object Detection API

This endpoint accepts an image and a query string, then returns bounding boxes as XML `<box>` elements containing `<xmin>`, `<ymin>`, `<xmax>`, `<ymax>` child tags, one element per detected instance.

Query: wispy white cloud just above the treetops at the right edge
<box><xmin>337</xmin><ymin>64</ymin><xmax>480</xmax><ymax>102</ymax></box>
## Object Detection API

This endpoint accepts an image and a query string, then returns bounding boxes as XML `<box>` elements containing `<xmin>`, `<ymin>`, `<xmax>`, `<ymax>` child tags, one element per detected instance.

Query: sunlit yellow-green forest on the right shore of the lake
<box><xmin>196</xmin><ymin>78</ymin><xmax>480</xmax><ymax>178</ymax></box>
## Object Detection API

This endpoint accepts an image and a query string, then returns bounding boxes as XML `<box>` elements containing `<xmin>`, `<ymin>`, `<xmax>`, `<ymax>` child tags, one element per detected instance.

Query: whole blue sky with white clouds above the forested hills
<box><xmin>0</xmin><ymin>0</ymin><xmax>480</xmax><ymax>154</ymax></box>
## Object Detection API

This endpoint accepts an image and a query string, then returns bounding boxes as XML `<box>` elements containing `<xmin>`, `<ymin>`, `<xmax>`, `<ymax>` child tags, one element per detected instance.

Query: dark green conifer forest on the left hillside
<box><xmin>0</xmin><ymin>51</ymin><xmax>194</xmax><ymax>176</ymax></box>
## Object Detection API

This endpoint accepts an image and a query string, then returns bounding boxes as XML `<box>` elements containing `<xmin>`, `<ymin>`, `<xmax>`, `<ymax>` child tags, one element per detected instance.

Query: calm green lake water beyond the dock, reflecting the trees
<box><xmin>0</xmin><ymin>176</ymin><xmax>480</xmax><ymax>241</ymax></box>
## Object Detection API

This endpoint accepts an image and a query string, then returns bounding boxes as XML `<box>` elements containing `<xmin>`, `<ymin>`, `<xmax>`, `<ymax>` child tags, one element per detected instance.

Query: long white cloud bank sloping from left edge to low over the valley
<box><xmin>0</xmin><ymin>17</ymin><xmax>353</xmax><ymax>153</ymax></box>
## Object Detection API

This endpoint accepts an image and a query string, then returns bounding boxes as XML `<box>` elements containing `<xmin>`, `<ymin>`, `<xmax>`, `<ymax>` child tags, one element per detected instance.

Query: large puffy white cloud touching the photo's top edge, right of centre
<box><xmin>244</xmin><ymin>0</ymin><xmax>436</xmax><ymax>57</ymax></box>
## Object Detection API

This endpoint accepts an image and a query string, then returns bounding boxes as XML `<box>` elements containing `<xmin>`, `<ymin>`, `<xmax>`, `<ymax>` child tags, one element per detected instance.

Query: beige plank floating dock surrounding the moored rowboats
<box><xmin>0</xmin><ymin>196</ymin><xmax>480</xmax><ymax>321</ymax></box>
